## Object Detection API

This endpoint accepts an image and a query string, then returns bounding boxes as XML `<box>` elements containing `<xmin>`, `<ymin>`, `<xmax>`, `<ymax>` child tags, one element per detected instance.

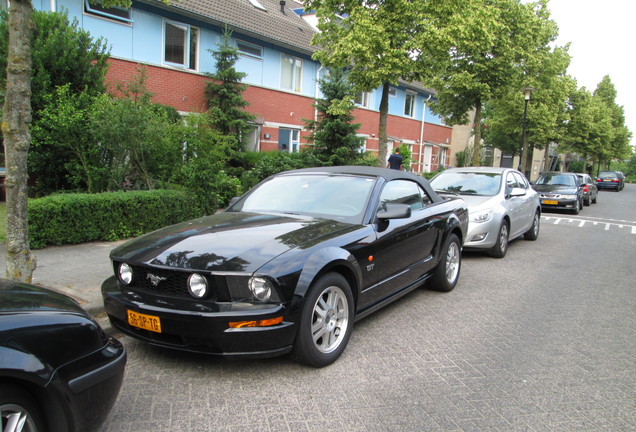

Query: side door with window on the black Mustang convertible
<box><xmin>359</xmin><ymin>180</ymin><xmax>438</xmax><ymax>309</ymax></box>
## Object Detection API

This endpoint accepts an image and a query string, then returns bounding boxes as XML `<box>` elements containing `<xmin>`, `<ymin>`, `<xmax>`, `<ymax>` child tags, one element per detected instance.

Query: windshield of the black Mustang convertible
<box><xmin>230</xmin><ymin>174</ymin><xmax>375</xmax><ymax>219</ymax></box>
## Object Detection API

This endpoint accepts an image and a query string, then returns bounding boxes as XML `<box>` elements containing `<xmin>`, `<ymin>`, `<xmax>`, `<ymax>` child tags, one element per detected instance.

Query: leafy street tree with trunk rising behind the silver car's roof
<box><xmin>427</xmin><ymin>0</ymin><xmax>557</xmax><ymax>169</ymax></box>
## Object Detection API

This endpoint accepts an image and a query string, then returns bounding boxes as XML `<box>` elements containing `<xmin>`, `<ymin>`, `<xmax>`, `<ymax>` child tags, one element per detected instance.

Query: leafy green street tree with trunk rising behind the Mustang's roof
<box><xmin>304</xmin><ymin>0</ymin><xmax>472</xmax><ymax>166</ymax></box>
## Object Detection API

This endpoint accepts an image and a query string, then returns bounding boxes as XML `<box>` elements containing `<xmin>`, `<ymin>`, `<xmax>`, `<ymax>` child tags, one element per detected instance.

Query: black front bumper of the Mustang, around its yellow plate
<box><xmin>102</xmin><ymin>277</ymin><xmax>296</xmax><ymax>357</ymax></box>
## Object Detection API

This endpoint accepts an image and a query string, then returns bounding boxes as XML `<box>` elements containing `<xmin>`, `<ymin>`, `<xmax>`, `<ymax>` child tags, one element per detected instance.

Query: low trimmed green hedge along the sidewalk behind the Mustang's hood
<box><xmin>28</xmin><ymin>190</ymin><xmax>203</xmax><ymax>249</ymax></box>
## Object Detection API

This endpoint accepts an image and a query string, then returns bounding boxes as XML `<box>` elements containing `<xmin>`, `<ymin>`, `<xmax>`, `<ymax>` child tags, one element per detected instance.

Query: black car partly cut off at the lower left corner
<box><xmin>0</xmin><ymin>279</ymin><xmax>126</xmax><ymax>432</ymax></box>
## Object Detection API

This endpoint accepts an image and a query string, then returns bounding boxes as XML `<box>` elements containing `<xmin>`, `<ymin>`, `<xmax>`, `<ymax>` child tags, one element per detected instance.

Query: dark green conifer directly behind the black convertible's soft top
<box><xmin>306</xmin><ymin>68</ymin><xmax>362</xmax><ymax>165</ymax></box>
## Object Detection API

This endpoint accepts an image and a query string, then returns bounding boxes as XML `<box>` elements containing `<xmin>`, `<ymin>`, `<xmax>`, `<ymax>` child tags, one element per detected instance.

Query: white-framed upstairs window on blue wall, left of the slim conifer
<box><xmin>164</xmin><ymin>21</ymin><xmax>199</xmax><ymax>70</ymax></box>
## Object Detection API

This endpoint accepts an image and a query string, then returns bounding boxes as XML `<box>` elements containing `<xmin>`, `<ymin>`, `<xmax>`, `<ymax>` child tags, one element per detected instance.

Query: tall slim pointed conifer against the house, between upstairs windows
<box><xmin>205</xmin><ymin>28</ymin><xmax>255</xmax><ymax>150</ymax></box>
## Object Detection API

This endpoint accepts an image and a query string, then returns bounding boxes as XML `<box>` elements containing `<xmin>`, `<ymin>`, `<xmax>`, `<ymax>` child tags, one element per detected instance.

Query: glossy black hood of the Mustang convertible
<box><xmin>110</xmin><ymin>212</ymin><xmax>359</xmax><ymax>273</ymax></box>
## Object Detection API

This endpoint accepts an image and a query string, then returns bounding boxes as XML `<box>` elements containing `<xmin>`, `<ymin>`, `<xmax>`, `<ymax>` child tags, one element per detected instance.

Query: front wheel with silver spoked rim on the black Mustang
<box><xmin>294</xmin><ymin>273</ymin><xmax>353</xmax><ymax>368</ymax></box>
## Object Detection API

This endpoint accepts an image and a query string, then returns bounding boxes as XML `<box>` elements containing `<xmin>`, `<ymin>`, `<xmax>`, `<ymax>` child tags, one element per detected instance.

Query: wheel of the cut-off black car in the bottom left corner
<box><xmin>0</xmin><ymin>384</ymin><xmax>44</xmax><ymax>432</ymax></box>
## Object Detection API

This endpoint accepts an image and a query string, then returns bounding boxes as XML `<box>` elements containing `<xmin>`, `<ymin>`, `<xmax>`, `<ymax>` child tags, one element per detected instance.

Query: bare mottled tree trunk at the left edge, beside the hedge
<box><xmin>2</xmin><ymin>0</ymin><xmax>35</xmax><ymax>282</ymax></box>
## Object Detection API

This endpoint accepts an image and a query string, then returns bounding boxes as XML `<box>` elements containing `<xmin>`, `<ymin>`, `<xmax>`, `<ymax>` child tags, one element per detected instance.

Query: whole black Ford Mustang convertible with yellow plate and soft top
<box><xmin>102</xmin><ymin>167</ymin><xmax>468</xmax><ymax>367</ymax></box>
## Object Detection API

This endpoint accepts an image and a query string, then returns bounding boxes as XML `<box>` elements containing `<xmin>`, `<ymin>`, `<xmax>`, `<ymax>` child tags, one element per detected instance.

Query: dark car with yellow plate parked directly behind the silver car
<box><xmin>533</xmin><ymin>172</ymin><xmax>583</xmax><ymax>214</ymax></box>
